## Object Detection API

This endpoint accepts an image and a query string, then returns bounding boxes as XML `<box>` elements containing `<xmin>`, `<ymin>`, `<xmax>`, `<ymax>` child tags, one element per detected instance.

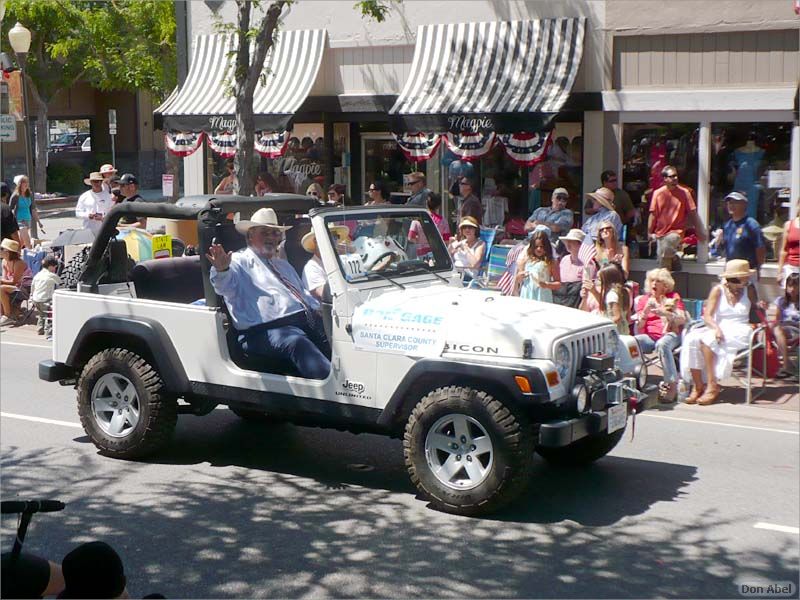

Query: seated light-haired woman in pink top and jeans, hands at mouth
<box><xmin>633</xmin><ymin>269</ymin><xmax>688</xmax><ymax>403</ymax></box>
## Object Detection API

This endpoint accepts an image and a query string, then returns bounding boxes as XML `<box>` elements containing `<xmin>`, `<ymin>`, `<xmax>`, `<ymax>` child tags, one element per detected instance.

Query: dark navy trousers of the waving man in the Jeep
<box><xmin>239</xmin><ymin>313</ymin><xmax>331</xmax><ymax>379</ymax></box>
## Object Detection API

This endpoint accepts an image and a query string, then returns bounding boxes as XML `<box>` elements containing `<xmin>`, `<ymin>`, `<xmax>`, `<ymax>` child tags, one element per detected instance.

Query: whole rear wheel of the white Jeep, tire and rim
<box><xmin>78</xmin><ymin>348</ymin><xmax>178</xmax><ymax>459</ymax></box>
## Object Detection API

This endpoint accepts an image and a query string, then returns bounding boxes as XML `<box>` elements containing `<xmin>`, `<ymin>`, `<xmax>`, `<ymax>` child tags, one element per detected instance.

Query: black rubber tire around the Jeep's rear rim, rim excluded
<box><xmin>78</xmin><ymin>348</ymin><xmax>178</xmax><ymax>459</ymax></box>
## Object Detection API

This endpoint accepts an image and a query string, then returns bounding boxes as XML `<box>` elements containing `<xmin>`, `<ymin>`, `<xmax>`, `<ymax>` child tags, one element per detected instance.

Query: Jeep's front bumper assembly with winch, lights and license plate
<box><xmin>538</xmin><ymin>353</ymin><xmax>648</xmax><ymax>447</ymax></box>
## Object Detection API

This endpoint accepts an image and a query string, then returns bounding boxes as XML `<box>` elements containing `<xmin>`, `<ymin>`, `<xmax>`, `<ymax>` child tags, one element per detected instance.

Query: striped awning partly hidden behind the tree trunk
<box><xmin>154</xmin><ymin>29</ymin><xmax>327</xmax><ymax>132</ymax></box>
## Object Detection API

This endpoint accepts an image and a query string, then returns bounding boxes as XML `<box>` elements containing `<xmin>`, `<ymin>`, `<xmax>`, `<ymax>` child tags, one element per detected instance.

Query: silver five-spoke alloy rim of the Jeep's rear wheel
<box><xmin>92</xmin><ymin>373</ymin><xmax>141</xmax><ymax>438</ymax></box>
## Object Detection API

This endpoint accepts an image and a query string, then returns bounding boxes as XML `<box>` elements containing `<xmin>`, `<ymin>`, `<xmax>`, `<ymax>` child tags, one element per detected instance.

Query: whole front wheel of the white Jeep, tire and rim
<box><xmin>403</xmin><ymin>387</ymin><xmax>534</xmax><ymax>516</ymax></box>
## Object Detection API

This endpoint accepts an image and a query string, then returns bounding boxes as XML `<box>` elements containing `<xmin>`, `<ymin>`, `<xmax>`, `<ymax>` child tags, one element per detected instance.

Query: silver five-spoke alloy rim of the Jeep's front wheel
<box><xmin>425</xmin><ymin>414</ymin><xmax>494</xmax><ymax>490</ymax></box>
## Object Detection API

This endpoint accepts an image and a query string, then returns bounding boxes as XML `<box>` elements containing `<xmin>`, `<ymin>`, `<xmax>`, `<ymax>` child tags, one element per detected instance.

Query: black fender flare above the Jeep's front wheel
<box><xmin>378</xmin><ymin>358</ymin><xmax>550</xmax><ymax>427</ymax></box>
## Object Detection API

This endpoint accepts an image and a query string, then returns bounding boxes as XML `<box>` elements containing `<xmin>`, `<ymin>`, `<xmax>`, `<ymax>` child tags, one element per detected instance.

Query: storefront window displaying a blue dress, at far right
<box><xmin>709</xmin><ymin>123</ymin><xmax>791</xmax><ymax>260</ymax></box>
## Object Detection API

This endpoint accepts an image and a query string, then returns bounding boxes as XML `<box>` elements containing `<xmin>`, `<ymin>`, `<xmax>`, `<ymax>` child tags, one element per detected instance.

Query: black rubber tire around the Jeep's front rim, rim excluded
<box><xmin>403</xmin><ymin>387</ymin><xmax>535</xmax><ymax>516</ymax></box>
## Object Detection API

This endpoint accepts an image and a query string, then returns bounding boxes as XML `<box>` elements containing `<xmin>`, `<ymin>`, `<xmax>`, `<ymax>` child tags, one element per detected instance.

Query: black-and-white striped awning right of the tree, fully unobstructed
<box><xmin>389</xmin><ymin>18</ymin><xmax>586</xmax><ymax>133</ymax></box>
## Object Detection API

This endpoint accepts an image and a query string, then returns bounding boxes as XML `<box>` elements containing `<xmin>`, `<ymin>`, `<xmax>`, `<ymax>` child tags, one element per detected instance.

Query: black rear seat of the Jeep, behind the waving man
<box><xmin>131</xmin><ymin>256</ymin><xmax>205</xmax><ymax>304</ymax></box>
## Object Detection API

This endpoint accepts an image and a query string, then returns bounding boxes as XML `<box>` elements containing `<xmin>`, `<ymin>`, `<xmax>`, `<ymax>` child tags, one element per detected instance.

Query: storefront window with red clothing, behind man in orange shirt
<box><xmin>622</xmin><ymin>123</ymin><xmax>700</xmax><ymax>245</ymax></box>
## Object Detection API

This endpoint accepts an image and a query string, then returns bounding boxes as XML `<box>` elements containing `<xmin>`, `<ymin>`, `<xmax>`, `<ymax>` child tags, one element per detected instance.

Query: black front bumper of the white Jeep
<box><xmin>538</xmin><ymin>377</ymin><xmax>649</xmax><ymax>448</ymax></box>
